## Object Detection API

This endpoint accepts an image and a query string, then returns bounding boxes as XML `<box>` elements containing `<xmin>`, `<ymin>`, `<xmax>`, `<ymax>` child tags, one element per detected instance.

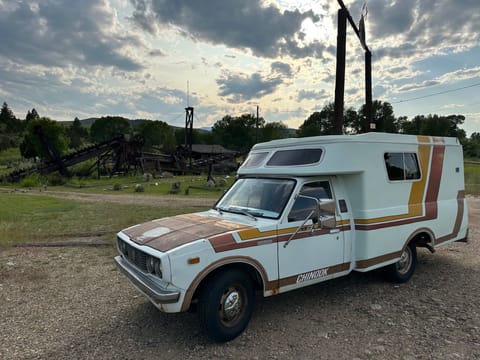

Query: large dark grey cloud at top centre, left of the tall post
<box><xmin>131</xmin><ymin>0</ymin><xmax>325</xmax><ymax>58</ymax></box>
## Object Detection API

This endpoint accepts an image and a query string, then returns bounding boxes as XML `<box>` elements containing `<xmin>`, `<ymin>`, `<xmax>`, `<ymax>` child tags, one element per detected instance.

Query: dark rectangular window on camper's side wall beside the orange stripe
<box><xmin>384</xmin><ymin>153</ymin><xmax>420</xmax><ymax>181</ymax></box>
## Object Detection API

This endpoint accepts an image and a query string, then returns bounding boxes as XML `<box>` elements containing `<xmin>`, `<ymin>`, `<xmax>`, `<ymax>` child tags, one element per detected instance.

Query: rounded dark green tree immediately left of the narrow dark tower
<box><xmin>135</xmin><ymin>120</ymin><xmax>175</xmax><ymax>153</ymax></box>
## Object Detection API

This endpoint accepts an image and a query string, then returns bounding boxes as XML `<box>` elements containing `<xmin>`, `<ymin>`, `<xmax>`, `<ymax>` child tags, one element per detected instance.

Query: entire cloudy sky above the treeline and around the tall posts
<box><xmin>0</xmin><ymin>0</ymin><xmax>480</xmax><ymax>135</ymax></box>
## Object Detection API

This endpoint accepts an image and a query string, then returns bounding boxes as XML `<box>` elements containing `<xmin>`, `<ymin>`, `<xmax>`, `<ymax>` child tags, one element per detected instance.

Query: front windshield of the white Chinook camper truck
<box><xmin>215</xmin><ymin>178</ymin><xmax>295</xmax><ymax>219</ymax></box>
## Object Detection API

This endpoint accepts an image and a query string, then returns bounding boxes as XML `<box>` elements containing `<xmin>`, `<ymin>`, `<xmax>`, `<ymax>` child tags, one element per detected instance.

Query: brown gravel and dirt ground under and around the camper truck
<box><xmin>0</xmin><ymin>197</ymin><xmax>480</xmax><ymax>360</ymax></box>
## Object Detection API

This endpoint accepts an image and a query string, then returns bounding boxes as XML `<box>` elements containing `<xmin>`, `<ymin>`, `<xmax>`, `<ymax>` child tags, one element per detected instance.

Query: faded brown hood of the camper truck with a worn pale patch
<box><xmin>122</xmin><ymin>214</ymin><xmax>249</xmax><ymax>252</ymax></box>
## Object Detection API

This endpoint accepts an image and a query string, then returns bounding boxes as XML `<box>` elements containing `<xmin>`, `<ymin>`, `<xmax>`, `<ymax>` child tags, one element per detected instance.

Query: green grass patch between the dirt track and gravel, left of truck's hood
<box><xmin>0</xmin><ymin>193</ymin><xmax>206</xmax><ymax>248</ymax></box>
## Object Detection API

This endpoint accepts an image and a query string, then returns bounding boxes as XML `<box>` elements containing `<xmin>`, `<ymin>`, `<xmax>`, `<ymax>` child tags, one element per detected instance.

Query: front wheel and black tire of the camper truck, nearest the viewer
<box><xmin>198</xmin><ymin>269</ymin><xmax>254</xmax><ymax>342</ymax></box>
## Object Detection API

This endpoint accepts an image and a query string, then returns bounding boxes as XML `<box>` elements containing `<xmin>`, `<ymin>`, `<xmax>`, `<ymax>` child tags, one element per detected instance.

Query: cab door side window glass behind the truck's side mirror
<box><xmin>288</xmin><ymin>181</ymin><xmax>335</xmax><ymax>222</ymax></box>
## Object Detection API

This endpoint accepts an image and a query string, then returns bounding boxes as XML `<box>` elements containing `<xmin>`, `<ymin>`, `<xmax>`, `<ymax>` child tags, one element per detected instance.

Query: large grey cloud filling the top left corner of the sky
<box><xmin>0</xmin><ymin>0</ymin><xmax>142</xmax><ymax>71</ymax></box>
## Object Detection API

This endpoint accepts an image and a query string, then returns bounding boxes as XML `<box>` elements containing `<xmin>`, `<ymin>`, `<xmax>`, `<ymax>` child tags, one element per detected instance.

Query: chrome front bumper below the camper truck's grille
<box><xmin>115</xmin><ymin>256</ymin><xmax>180</xmax><ymax>307</ymax></box>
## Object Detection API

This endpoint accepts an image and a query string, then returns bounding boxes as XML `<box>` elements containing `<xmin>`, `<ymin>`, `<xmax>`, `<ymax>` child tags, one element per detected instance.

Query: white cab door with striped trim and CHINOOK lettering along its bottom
<box><xmin>278</xmin><ymin>181</ymin><xmax>348</xmax><ymax>290</ymax></box>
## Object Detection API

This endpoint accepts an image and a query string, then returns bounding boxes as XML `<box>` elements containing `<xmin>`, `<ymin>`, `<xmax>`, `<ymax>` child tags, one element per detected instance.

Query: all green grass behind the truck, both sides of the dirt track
<box><xmin>0</xmin><ymin>154</ymin><xmax>480</xmax><ymax>248</ymax></box>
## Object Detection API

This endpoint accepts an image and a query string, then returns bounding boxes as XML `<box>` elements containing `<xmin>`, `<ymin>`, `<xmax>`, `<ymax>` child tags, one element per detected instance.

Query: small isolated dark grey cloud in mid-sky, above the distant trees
<box><xmin>217</xmin><ymin>73</ymin><xmax>283</xmax><ymax>103</ymax></box>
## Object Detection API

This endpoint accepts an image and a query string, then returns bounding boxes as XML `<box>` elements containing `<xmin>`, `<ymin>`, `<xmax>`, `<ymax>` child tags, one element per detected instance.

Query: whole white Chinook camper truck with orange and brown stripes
<box><xmin>115</xmin><ymin>133</ymin><xmax>468</xmax><ymax>341</ymax></box>
